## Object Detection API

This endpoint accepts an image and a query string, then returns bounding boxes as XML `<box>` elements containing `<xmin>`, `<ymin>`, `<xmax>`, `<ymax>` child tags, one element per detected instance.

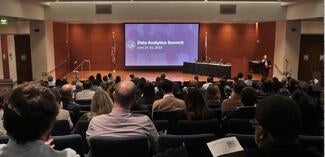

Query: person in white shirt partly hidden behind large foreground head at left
<box><xmin>51</xmin><ymin>88</ymin><xmax>73</xmax><ymax>129</ymax></box>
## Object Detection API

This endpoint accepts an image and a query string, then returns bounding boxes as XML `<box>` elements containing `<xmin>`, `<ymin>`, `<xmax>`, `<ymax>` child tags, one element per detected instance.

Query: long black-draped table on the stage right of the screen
<box><xmin>183</xmin><ymin>62</ymin><xmax>231</xmax><ymax>78</ymax></box>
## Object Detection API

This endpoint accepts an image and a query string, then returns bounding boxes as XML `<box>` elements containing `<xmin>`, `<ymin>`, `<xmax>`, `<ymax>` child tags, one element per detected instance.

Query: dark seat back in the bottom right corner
<box><xmin>299</xmin><ymin>135</ymin><xmax>324</xmax><ymax>154</ymax></box>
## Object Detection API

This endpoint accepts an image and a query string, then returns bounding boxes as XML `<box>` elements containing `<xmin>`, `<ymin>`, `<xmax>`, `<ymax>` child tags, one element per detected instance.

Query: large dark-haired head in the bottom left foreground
<box><xmin>3</xmin><ymin>83</ymin><xmax>58</xmax><ymax>144</ymax></box>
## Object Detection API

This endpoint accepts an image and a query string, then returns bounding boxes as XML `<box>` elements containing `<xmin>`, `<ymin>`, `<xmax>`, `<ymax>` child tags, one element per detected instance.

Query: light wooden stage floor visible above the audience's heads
<box><xmin>67</xmin><ymin>70</ymin><xmax>261</xmax><ymax>81</ymax></box>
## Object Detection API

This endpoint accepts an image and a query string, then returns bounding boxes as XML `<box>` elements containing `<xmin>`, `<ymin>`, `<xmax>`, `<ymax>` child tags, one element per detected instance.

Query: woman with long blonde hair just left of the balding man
<box><xmin>77</xmin><ymin>90</ymin><xmax>113</xmax><ymax>124</ymax></box>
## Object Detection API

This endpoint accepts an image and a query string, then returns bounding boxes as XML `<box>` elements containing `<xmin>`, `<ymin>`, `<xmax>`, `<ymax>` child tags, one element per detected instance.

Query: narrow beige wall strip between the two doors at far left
<box><xmin>7</xmin><ymin>35</ymin><xmax>17</xmax><ymax>82</ymax></box>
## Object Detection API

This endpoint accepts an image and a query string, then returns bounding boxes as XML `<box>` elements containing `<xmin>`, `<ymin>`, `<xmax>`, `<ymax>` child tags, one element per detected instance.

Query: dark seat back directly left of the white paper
<box><xmin>158</xmin><ymin>134</ymin><xmax>215</xmax><ymax>157</ymax></box>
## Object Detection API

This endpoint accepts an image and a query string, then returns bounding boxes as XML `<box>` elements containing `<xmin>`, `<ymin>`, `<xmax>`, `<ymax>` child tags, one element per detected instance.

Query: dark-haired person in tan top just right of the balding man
<box><xmin>152</xmin><ymin>79</ymin><xmax>185</xmax><ymax>111</ymax></box>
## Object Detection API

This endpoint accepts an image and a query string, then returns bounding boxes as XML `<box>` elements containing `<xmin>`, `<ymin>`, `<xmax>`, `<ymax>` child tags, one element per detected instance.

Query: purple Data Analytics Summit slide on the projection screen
<box><xmin>125</xmin><ymin>24</ymin><xmax>199</xmax><ymax>66</ymax></box>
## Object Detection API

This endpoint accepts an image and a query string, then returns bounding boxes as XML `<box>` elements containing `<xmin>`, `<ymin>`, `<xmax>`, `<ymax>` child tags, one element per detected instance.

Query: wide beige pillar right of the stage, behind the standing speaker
<box><xmin>273</xmin><ymin>21</ymin><xmax>301</xmax><ymax>79</ymax></box>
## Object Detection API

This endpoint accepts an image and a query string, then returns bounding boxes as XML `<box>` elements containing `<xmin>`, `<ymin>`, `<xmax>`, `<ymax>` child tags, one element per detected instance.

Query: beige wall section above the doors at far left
<box><xmin>0</xmin><ymin>21</ymin><xmax>29</xmax><ymax>34</ymax></box>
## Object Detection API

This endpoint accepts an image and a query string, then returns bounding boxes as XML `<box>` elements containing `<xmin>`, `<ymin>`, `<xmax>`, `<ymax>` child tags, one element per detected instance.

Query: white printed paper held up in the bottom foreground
<box><xmin>207</xmin><ymin>137</ymin><xmax>244</xmax><ymax>157</ymax></box>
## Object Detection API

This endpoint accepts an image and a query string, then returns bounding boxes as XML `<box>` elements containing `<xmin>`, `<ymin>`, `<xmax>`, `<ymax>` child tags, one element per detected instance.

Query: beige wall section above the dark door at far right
<box><xmin>301</xmin><ymin>21</ymin><xmax>324</xmax><ymax>34</ymax></box>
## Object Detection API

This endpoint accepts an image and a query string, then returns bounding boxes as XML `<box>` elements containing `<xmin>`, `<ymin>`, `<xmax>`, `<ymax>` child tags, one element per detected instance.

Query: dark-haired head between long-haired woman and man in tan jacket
<box><xmin>205</xmin><ymin>84</ymin><xmax>221</xmax><ymax>108</ymax></box>
